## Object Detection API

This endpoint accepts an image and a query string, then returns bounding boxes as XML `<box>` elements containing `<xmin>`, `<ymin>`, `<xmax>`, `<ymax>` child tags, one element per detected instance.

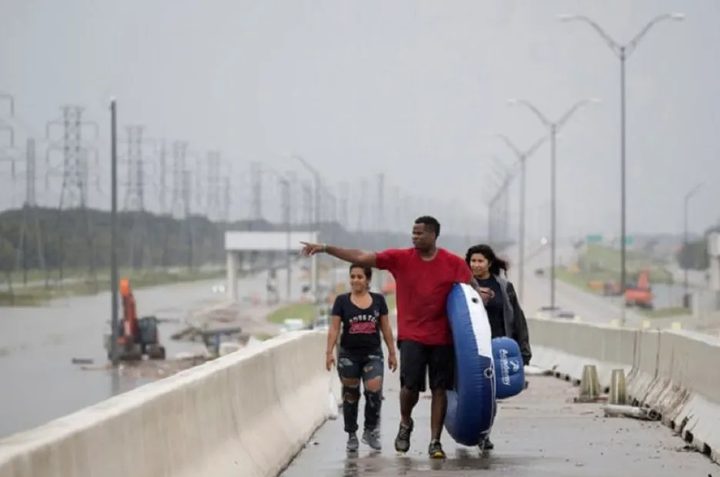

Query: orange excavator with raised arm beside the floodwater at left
<box><xmin>107</xmin><ymin>278</ymin><xmax>165</xmax><ymax>361</ymax></box>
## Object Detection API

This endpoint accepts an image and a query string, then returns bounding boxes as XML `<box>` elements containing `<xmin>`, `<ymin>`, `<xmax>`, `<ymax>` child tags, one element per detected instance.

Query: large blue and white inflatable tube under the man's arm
<box><xmin>445</xmin><ymin>284</ymin><xmax>495</xmax><ymax>446</ymax></box>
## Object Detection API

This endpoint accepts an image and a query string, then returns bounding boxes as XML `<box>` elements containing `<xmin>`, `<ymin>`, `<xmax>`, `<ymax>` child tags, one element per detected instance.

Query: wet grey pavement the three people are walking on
<box><xmin>281</xmin><ymin>376</ymin><xmax>720</xmax><ymax>477</ymax></box>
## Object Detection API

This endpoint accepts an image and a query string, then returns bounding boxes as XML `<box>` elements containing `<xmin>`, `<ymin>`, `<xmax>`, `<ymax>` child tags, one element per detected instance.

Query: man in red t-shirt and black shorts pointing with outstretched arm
<box><xmin>303</xmin><ymin>216</ymin><xmax>492</xmax><ymax>459</ymax></box>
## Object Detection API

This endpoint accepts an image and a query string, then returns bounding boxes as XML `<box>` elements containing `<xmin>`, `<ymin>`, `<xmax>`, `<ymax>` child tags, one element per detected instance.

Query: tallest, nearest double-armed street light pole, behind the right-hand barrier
<box><xmin>558</xmin><ymin>13</ymin><xmax>685</xmax><ymax>325</ymax></box>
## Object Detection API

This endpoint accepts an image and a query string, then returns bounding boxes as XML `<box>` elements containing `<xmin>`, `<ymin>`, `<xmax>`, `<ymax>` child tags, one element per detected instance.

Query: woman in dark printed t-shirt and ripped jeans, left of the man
<box><xmin>325</xmin><ymin>265</ymin><xmax>397</xmax><ymax>452</ymax></box>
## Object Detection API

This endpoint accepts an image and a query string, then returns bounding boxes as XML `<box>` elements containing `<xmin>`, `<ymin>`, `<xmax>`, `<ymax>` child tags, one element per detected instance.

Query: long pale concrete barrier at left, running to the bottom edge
<box><xmin>0</xmin><ymin>332</ymin><xmax>335</xmax><ymax>477</ymax></box>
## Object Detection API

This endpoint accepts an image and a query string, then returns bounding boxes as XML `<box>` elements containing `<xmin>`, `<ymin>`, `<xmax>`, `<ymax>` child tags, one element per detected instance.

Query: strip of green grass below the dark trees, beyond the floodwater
<box><xmin>0</xmin><ymin>269</ymin><xmax>224</xmax><ymax>306</ymax></box>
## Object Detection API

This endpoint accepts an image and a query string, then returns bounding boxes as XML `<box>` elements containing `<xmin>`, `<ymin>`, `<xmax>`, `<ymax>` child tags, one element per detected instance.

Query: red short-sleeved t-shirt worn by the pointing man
<box><xmin>376</xmin><ymin>248</ymin><xmax>471</xmax><ymax>346</ymax></box>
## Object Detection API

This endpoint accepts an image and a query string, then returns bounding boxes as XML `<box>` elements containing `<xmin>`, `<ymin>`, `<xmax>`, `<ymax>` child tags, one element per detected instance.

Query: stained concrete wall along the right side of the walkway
<box><xmin>528</xmin><ymin>319</ymin><xmax>720</xmax><ymax>461</ymax></box>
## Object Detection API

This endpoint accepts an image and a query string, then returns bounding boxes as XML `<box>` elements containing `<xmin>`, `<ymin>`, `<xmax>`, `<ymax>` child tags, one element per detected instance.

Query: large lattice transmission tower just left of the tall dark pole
<box><xmin>46</xmin><ymin>106</ymin><xmax>98</xmax><ymax>288</ymax></box>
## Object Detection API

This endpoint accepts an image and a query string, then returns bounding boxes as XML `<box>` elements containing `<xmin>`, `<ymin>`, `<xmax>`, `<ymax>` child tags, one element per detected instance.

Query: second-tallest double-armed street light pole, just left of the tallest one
<box><xmin>508</xmin><ymin>99</ymin><xmax>599</xmax><ymax>310</ymax></box>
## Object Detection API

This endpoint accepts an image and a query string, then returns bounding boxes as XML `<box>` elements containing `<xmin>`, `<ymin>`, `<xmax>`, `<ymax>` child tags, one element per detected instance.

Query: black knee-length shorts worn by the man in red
<box><xmin>398</xmin><ymin>340</ymin><xmax>455</xmax><ymax>391</ymax></box>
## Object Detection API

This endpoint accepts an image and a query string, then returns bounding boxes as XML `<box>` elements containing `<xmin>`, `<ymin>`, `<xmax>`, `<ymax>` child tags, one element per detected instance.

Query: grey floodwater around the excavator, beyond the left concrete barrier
<box><xmin>0</xmin><ymin>280</ymin><xmax>224</xmax><ymax>437</ymax></box>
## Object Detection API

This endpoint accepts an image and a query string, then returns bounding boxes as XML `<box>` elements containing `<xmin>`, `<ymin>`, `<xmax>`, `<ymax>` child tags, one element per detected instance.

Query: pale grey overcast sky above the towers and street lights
<box><xmin>0</xmin><ymin>0</ymin><xmax>720</xmax><ymax>235</ymax></box>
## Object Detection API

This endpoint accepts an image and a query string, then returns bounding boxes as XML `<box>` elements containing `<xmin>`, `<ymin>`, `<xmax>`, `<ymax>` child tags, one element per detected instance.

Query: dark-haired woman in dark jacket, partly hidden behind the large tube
<box><xmin>465</xmin><ymin>244</ymin><xmax>532</xmax><ymax>449</ymax></box>
